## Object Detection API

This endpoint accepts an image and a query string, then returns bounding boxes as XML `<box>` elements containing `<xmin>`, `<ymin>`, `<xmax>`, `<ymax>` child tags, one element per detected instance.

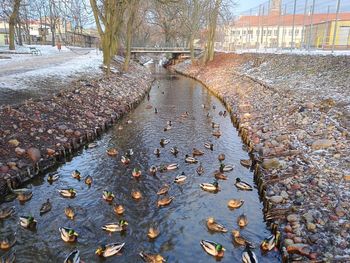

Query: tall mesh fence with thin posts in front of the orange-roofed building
<box><xmin>221</xmin><ymin>0</ymin><xmax>350</xmax><ymax>52</ymax></box>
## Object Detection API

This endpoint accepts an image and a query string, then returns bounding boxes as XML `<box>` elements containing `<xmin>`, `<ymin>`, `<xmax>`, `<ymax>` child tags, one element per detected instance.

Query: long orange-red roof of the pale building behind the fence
<box><xmin>232</xmin><ymin>13</ymin><xmax>350</xmax><ymax>27</ymax></box>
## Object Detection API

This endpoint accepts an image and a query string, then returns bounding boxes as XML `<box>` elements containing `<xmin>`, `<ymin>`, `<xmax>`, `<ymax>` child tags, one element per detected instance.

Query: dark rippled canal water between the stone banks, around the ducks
<box><xmin>0</xmin><ymin>67</ymin><xmax>280</xmax><ymax>263</ymax></box>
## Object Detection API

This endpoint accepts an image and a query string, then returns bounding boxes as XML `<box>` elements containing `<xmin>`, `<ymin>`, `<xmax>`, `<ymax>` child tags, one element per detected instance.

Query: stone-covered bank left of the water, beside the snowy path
<box><xmin>0</xmin><ymin>59</ymin><xmax>153</xmax><ymax>197</ymax></box>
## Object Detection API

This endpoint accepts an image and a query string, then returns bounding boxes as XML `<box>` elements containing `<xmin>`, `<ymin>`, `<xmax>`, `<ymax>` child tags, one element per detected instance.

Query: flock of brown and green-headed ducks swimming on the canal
<box><xmin>0</xmin><ymin>89</ymin><xmax>280</xmax><ymax>263</ymax></box>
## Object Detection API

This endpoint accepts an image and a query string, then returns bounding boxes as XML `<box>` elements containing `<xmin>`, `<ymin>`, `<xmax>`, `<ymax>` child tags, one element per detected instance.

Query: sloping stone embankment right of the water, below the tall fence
<box><xmin>175</xmin><ymin>54</ymin><xmax>350</xmax><ymax>262</ymax></box>
